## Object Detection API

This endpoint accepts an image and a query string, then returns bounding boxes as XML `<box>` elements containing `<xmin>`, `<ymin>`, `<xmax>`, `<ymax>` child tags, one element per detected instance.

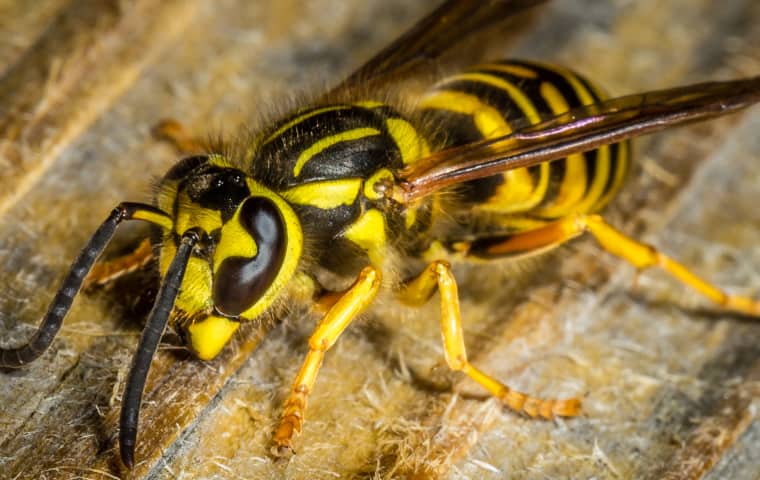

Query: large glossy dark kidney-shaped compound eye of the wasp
<box><xmin>213</xmin><ymin>197</ymin><xmax>287</xmax><ymax>316</ymax></box>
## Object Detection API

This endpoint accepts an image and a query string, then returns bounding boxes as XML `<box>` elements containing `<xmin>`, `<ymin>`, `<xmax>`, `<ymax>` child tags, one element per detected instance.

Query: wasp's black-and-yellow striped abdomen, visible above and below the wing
<box><xmin>419</xmin><ymin>61</ymin><xmax>629</xmax><ymax>231</ymax></box>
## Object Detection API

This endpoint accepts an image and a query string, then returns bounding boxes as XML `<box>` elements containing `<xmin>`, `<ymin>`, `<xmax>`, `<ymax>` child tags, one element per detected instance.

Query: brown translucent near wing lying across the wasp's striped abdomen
<box><xmin>394</xmin><ymin>76</ymin><xmax>760</xmax><ymax>202</ymax></box>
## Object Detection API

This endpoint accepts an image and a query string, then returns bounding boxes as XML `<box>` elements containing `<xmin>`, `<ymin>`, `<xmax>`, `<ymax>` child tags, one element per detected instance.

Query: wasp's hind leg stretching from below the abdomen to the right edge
<box><xmin>467</xmin><ymin>214</ymin><xmax>760</xmax><ymax>316</ymax></box>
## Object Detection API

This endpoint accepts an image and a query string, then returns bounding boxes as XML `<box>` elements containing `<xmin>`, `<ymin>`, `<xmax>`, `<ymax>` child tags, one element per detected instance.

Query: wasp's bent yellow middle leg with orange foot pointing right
<box><xmin>400</xmin><ymin>260</ymin><xmax>581</xmax><ymax>419</ymax></box>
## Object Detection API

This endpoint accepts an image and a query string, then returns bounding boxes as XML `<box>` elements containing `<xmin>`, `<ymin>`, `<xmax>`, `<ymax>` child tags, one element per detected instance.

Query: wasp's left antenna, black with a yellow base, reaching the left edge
<box><xmin>0</xmin><ymin>203</ymin><xmax>171</xmax><ymax>368</ymax></box>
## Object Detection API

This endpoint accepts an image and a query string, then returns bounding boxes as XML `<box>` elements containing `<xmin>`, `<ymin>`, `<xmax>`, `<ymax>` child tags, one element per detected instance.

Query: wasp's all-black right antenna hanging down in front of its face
<box><xmin>119</xmin><ymin>230</ymin><xmax>200</xmax><ymax>469</ymax></box>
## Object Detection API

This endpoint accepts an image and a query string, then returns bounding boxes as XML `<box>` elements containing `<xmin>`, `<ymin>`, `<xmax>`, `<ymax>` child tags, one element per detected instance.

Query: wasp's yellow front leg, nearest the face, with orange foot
<box><xmin>272</xmin><ymin>267</ymin><xmax>380</xmax><ymax>456</ymax></box>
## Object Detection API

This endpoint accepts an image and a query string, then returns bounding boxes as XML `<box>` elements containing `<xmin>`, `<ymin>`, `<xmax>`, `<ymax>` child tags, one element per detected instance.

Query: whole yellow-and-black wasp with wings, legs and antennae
<box><xmin>0</xmin><ymin>0</ymin><xmax>760</xmax><ymax>467</ymax></box>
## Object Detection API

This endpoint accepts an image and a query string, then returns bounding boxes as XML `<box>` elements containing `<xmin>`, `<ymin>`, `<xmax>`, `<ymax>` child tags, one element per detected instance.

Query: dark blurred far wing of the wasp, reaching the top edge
<box><xmin>328</xmin><ymin>0</ymin><xmax>547</xmax><ymax>96</ymax></box>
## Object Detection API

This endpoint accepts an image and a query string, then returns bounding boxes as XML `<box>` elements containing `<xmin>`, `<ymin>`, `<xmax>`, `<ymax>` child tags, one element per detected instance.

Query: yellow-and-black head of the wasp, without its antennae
<box><xmin>159</xmin><ymin>156</ymin><xmax>303</xmax><ymax>359</ymax></box>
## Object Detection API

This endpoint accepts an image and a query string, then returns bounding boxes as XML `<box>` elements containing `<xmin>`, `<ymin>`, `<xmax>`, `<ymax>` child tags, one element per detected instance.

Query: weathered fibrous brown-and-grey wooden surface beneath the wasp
<box><xmin>0</xmin><ymin>0</ymin><xmax>760</xmax><ymax>479</ymax></box>
